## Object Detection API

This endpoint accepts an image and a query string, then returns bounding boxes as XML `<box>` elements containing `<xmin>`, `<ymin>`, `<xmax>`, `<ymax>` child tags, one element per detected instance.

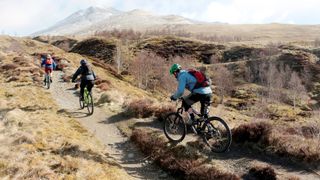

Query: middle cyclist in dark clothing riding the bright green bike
<box><xmin>72</xmin><ymin>59</ymin><xmax>96</xmax><ymax>100</ymax></box>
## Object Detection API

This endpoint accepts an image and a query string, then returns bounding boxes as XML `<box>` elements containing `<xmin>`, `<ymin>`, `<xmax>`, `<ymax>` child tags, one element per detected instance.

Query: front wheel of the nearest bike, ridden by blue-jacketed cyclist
<box><xmin>163</xmin><ymin>113</ymin><xmax>187</xmax><ymax>143</ymax></box>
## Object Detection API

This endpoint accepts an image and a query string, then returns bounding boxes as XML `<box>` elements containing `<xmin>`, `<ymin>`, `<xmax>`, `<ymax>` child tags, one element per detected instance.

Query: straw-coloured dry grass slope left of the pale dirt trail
<box><xmin>0</xmin><ymin>46</ymin><xmax>130</xmax><ymax>179</ymax></box>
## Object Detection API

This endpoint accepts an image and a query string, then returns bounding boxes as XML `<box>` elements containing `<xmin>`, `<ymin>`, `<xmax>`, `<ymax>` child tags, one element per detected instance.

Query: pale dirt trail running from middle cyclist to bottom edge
<box><xmin>49</xmin><ymin>72</ymin><xmax>170</xmax><ymax>179</ymax></box>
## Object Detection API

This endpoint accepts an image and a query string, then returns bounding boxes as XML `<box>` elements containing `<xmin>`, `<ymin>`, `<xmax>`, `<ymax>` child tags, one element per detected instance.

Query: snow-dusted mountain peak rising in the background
<box><xmin>33</xmin><ymin>7</ymin><xmax>196</xmax><ymax>36</ymax></box>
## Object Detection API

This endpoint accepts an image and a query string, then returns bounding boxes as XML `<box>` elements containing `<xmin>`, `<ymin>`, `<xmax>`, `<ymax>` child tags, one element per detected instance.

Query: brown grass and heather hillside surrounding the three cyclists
<box><xmin>0</xmin><ymin>33</ymin><xmax>320</xmax><ymax>179</ymax></box>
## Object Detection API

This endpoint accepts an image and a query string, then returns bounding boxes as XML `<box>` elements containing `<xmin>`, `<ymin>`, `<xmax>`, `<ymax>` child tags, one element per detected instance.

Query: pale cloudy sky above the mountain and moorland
<box><xmin>0</xmin><ymin>0</ymin><xmax>320</xmax><ymax>35</ymax></box>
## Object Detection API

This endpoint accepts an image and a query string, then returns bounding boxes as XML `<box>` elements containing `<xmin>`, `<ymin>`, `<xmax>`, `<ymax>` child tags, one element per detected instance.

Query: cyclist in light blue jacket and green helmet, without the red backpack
<box><xmin>170</xmin><ymin>64</ymin><xmax>212</xmax><ymax>125</ymax></box>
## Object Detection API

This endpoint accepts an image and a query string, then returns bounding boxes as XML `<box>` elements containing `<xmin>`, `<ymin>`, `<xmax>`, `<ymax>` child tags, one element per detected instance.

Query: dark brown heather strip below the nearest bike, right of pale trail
<box><xmin>131</xmin><ymin>129</ymin><xmax>240</xmax><ymax>180</ymax></box>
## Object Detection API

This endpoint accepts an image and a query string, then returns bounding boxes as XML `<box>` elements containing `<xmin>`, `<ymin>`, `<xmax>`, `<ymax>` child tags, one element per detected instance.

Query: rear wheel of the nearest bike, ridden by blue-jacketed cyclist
<box><xmin>202</xmin><ymin>117</ymin><xmax>232</xmax><ymax>153</ymax></box>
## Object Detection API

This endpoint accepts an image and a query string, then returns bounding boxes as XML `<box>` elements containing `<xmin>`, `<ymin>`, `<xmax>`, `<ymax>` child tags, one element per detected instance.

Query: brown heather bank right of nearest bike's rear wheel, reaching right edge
<box><xmin>233</xmin><ymin>122</ymin><xmax>320</xmax><ymax>163</ymax></box>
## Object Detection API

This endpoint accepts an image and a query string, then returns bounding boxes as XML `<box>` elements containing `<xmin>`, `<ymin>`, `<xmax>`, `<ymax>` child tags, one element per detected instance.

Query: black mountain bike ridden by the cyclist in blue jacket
<box><xmin>163</xmin><ymin>98</ymin><xmax>232</xmax><ymax>153</ymax></box>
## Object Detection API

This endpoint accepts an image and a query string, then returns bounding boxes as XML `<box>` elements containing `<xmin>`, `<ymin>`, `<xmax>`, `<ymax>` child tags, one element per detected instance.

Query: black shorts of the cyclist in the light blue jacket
<box><xmin>182</xmin><ymin>93</ymin><xmax>212</xmax><ymax>115</ymax></box>
